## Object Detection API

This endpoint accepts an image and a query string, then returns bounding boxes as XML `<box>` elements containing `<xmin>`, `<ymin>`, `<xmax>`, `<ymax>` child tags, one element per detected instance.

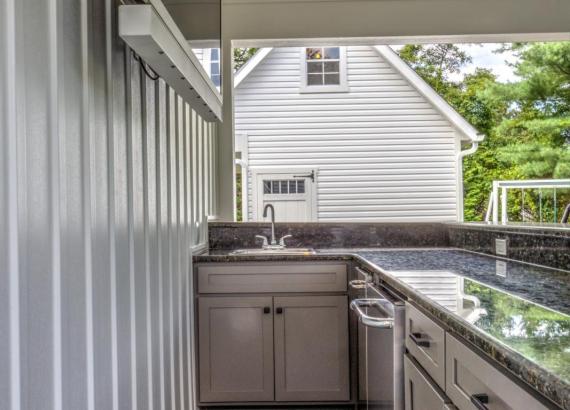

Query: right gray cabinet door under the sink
<box><xmin>274</xmin><ymin>296</ymin><xmax>350</xmax><ymax>401</ymax></box>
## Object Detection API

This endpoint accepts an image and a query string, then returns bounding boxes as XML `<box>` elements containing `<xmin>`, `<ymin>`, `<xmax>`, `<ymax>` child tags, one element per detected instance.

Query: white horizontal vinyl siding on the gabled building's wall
<box><xmin>235</xmin><ymin>47</ymin><xmax>459</xmax><ymax>222</ymax></box>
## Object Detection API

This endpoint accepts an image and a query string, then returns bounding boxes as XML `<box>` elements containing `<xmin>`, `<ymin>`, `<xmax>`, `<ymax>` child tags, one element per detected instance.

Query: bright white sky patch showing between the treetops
<box><xmin>393</xmin><ymin>43</ymin><xmax>517</xmax><ymax>82</ymax></box>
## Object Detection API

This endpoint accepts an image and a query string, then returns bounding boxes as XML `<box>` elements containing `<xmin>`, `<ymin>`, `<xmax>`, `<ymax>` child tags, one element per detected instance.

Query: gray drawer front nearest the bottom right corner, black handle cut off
<box><xmin>445</xmin><ymin>334</ymin><xmax>547</xmax><ymax>410</ymax></box>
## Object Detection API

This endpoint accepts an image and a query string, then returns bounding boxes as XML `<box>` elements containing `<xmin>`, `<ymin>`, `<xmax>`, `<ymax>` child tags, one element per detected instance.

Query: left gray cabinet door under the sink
<box><xmin>198</xmin><ymin>296</ymin><xmax>274</xmax><ymax>402</ymax></box>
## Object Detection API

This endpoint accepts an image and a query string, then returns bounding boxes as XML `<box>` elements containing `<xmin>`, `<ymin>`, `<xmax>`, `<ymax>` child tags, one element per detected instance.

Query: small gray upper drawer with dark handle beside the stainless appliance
<box><xmin>406</xmin><ymin>303</ymin><xmax>445</xmax><ymax>389</ymax></box>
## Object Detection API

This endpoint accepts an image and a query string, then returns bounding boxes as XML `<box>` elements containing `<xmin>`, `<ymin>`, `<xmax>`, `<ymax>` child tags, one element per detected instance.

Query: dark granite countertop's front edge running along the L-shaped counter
<box><xmin>193</xmin><ymin>248</ymin><xmax>570</xmax><ymax>410</ymax></box>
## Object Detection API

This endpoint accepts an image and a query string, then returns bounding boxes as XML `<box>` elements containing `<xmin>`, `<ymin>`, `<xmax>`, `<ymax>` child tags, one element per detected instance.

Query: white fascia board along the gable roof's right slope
<box><xmin>374</xmin><ymin>46</ymin><xmax>485</xmax><ymax>142</ymax></box>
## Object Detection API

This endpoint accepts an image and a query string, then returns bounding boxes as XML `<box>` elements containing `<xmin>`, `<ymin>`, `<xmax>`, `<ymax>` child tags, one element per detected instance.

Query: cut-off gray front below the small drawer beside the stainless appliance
<box><xmin>404</xmin><ymin>355</ymin><xmax>455</xmax><ymax>410</ymax></box>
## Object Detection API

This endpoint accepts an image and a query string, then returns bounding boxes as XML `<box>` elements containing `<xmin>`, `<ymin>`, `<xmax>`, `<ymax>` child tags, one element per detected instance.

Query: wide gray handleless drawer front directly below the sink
<box><xmin>197</xmin><ymin>263</ymin><xmax>347</xmax><ymax>293</ymax></box>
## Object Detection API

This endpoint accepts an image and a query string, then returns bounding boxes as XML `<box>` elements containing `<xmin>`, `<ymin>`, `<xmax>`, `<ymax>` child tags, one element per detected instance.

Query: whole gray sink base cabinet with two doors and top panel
<box><xmin>196</xmin><ymin>263</ymin><xmax>350</xmax><ymax>404</ymax></box>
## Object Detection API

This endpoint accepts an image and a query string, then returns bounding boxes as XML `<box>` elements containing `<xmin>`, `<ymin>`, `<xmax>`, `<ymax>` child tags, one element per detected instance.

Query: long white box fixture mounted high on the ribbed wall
<box><xmin>119</xmin><ymin>4</ymin><xmax>222</xmax><ymax>121</ymax></box>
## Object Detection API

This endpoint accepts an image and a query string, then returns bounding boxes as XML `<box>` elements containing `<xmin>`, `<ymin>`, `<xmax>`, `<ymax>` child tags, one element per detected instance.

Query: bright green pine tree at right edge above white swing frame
<box><xmin>485</xmin><ymin>42</ymin><xmax>570</xmax><ymax>178</ymax></box>
